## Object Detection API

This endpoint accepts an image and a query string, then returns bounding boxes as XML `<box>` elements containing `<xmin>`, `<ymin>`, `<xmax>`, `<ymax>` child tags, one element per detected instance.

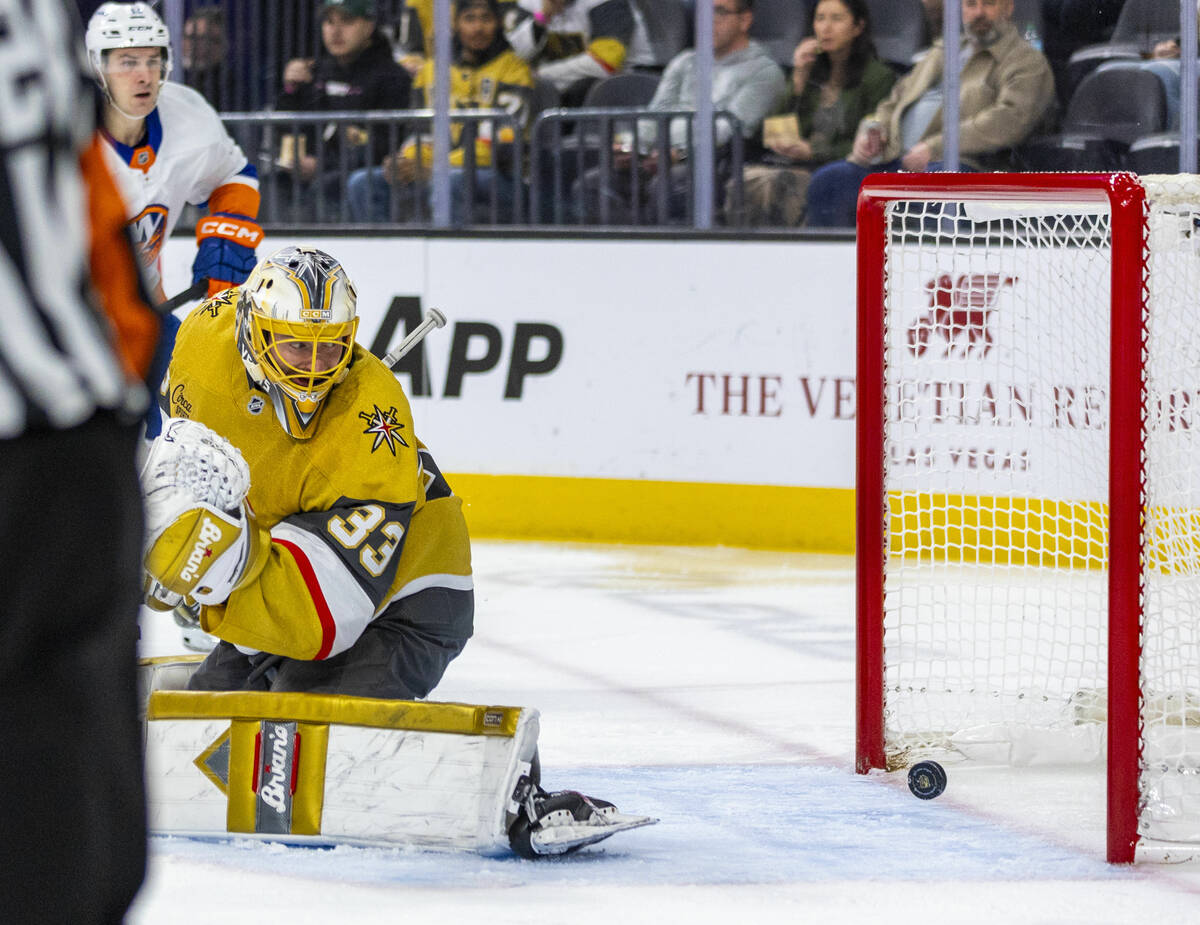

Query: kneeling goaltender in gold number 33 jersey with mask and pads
<box><xmin>142</xmin><ymin>247</ymin><xmax>655</xmax><ymax>858</ymax></box>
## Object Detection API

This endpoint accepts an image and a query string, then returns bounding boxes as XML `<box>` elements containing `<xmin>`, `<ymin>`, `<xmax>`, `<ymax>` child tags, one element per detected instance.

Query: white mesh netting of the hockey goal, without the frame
<box><xmin>883</xmin><ymin>178</ymin><xmax>1200</xmax><ymax>841</ymax></box>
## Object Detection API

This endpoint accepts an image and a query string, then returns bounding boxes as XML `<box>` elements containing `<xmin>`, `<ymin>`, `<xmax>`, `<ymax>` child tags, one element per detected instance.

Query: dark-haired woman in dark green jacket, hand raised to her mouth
<box><xmin>725</xmin><ymin>0</ymin><xmax>895</xmax><ymax>227</ymax></box>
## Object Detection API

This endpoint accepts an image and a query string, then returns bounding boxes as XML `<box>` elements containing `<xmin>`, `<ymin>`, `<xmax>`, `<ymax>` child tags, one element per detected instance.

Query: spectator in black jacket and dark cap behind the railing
<box><xmin>266</xmin><ymin>0</ymin><xmax>413</xmax><ymax>221</ymax></box>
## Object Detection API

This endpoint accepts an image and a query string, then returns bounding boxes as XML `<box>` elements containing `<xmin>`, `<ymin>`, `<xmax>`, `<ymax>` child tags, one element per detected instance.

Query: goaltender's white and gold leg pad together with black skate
<box><xmin>142</xmin><ymin>656</ymin><xmax>658</xmax><ymax>858</ymax></box>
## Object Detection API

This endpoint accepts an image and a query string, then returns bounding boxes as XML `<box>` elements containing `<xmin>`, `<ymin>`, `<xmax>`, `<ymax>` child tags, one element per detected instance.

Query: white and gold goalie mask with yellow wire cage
<box><xmin>236</xmin><ymin>247</ymin><xmax>359</xmax><ymax>440</ymax></box>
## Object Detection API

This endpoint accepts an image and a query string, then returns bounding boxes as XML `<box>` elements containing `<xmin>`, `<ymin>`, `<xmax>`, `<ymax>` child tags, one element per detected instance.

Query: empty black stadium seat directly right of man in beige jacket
<box><xmin>1019</xmin><ymin>65</ymin><xmax>1166</xmax><ymax>170</ymax></box>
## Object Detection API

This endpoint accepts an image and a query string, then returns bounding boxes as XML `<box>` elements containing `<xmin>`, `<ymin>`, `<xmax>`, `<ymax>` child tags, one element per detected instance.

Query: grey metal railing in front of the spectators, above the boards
<box><xmin>222</xmin><ymin>107</ymin><xmax>745</xmax><ymax>228</ymax></box>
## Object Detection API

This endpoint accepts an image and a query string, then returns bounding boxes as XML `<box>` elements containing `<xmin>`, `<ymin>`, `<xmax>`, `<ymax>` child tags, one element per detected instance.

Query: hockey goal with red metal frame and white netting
<box><xmin>856</xmin><ymin>174</ymin><xmax>1200</xmax><ymax>861</ymax></box>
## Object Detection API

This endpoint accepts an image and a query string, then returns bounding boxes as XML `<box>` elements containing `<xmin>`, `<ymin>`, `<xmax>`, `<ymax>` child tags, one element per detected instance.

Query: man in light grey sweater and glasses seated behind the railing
<box><xmin>575</xmin><ymin>0</ymin><xmax>787</xmax><ymax>224</ymax></box>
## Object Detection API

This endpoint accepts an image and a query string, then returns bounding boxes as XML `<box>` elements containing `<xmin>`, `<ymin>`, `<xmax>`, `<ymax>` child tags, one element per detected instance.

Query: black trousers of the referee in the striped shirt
<box><xmin>0</xmin><ymin>414</ymin><xmax>146</xmax><ymax>925</ymax></box>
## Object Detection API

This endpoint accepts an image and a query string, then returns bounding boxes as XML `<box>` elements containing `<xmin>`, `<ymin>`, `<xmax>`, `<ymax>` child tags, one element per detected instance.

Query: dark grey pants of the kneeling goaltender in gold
<box><xmin>187</xmin><ymin>588</ymin><xmax>475</xmax><ymax>699</ymax></box>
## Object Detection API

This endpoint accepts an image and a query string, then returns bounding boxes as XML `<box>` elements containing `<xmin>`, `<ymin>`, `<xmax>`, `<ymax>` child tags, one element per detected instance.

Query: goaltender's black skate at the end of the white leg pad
<box><xmin>509</xmin><ymin>786</ymin><xmax>658</xmax><ymax>860</ymax></box>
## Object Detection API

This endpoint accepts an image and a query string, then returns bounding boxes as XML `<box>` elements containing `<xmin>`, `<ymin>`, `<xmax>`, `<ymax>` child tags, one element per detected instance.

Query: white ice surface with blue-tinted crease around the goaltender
<box><xmin>130</xmin><ymin>542</ymin><xmax>1200</xmax><ymax>925</ymax></box>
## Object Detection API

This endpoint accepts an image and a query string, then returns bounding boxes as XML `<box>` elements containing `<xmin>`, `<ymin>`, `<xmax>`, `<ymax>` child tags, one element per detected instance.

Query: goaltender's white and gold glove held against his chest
<box><xmin>142</xmin><ymin>418</ymin><xmax>270</xmax><ymax>609</ymax></box>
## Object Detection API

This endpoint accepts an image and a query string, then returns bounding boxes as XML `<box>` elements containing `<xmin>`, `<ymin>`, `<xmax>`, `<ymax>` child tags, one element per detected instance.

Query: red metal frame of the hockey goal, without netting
<box><xmin>856</xmin><ymin>173</ymin><xmax>1148</xmax><ymax>863</ymax></box>
